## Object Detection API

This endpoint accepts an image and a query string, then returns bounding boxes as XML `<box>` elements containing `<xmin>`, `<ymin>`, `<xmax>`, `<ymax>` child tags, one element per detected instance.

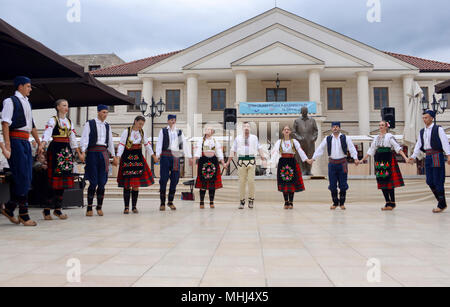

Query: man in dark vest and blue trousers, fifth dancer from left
<box><xmin>156</xmin><ymin>114</ymin><xmax>192</xmax><ymax>211</ymax></box>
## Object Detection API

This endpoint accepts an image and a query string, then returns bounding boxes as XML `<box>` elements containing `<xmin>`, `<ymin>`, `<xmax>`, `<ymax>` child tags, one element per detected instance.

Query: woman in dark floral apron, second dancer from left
<box><xmin>41</xmin><ymin>99</ymin><xmax>80</xmax><ymax>220</ymax></box>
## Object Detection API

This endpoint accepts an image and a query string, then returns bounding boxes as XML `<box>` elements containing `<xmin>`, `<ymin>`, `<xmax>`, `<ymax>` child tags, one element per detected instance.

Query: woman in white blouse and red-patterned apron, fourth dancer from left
<box><xmin>117</xmin><ymin>116</ymin><xmax>157</xmax><ymax>214</ymax></box>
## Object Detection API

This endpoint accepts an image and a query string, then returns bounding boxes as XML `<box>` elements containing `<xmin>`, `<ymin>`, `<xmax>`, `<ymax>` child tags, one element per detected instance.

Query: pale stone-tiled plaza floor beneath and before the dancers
<box><xmin>0</xmin><ymin>180</ymin><xmax>450</xmax><ymax>287</ymax></box>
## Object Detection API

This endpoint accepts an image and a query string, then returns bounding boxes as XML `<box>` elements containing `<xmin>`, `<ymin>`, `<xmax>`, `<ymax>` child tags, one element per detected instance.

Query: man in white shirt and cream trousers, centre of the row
<box><xmin>225</xmin><ymin>122</ymin><xmax>266</xmax><ymax>209</ymax></box>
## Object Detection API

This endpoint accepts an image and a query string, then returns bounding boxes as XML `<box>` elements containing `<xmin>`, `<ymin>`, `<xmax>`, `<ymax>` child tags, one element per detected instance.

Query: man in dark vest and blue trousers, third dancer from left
<box><xmin>80</xmin><ymin>105</ymin><xmax>118</xmax><ymax>216</ymax></box>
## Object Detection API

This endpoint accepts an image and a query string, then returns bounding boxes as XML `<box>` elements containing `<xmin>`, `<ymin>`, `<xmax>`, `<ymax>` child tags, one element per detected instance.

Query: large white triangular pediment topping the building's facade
<box><xmin>140</xmin><ymin>8</ymin><xmax>418</xmax><ymax>74</ymax></box>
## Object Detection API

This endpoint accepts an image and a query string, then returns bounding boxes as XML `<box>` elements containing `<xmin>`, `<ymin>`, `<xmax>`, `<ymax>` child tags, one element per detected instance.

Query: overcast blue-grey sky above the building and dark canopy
<box><xmin>0</xmin><ymin>0</ymin><xmax>450</xmax><ymax>63</ymax></box>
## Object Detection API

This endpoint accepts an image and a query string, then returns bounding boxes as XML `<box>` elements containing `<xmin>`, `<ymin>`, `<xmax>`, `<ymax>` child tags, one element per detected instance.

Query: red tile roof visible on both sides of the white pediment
<box><xmin>91</xmin><ymin>50</ymin><xmax>450</xmax><ymax>77</ymax></box>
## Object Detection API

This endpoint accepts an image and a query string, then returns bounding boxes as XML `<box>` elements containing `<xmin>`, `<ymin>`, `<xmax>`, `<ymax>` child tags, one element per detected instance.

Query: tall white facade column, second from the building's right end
<box><xmin>356</xmin><ymin>71</ymin><xmax>370</xmax><ymax>135</ymax></box>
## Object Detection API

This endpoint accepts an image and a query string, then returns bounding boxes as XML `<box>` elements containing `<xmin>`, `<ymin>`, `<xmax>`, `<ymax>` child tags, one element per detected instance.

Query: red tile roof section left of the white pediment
<box><xmin>91</xmin><ymin>51</ymin><xmax>180</xmax><ymax>77</ymax></box>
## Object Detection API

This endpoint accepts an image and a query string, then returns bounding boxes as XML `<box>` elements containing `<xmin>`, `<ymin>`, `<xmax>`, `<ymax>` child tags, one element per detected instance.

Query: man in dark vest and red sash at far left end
<box><xmin>1</xmin><ymin>77</ymin><xmax>41</xmax><ymax>226</ymax></box>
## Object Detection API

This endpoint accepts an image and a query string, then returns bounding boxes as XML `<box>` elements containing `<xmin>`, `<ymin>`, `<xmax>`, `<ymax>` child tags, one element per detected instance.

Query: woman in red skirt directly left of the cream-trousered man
<box><xmin>194</xmin><ymin>127</ymin><xmax>225</xmax><ymax>209</ymax></box>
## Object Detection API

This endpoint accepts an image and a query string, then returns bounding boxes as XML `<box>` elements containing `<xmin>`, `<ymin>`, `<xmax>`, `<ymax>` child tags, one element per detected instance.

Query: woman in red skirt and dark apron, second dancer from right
<box><xmin>362</xmin><ymin>120</ymin><xmax>408</xmax><ymax>211</ymax></box>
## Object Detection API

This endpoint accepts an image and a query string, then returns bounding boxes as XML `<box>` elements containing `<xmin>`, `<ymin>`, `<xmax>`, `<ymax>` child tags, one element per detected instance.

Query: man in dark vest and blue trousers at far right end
<box><xmin>408</xmin><ymin>110</ymin><xmax>450</xmax><ymax>213</ymax></box>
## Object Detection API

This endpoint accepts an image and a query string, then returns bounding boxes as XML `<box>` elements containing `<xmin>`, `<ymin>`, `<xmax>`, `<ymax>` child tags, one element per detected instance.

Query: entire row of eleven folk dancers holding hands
<box><xmin>1</xmin><ymin>77</ymin><xmax>450</xmax><ymax>226</ymax></box>
